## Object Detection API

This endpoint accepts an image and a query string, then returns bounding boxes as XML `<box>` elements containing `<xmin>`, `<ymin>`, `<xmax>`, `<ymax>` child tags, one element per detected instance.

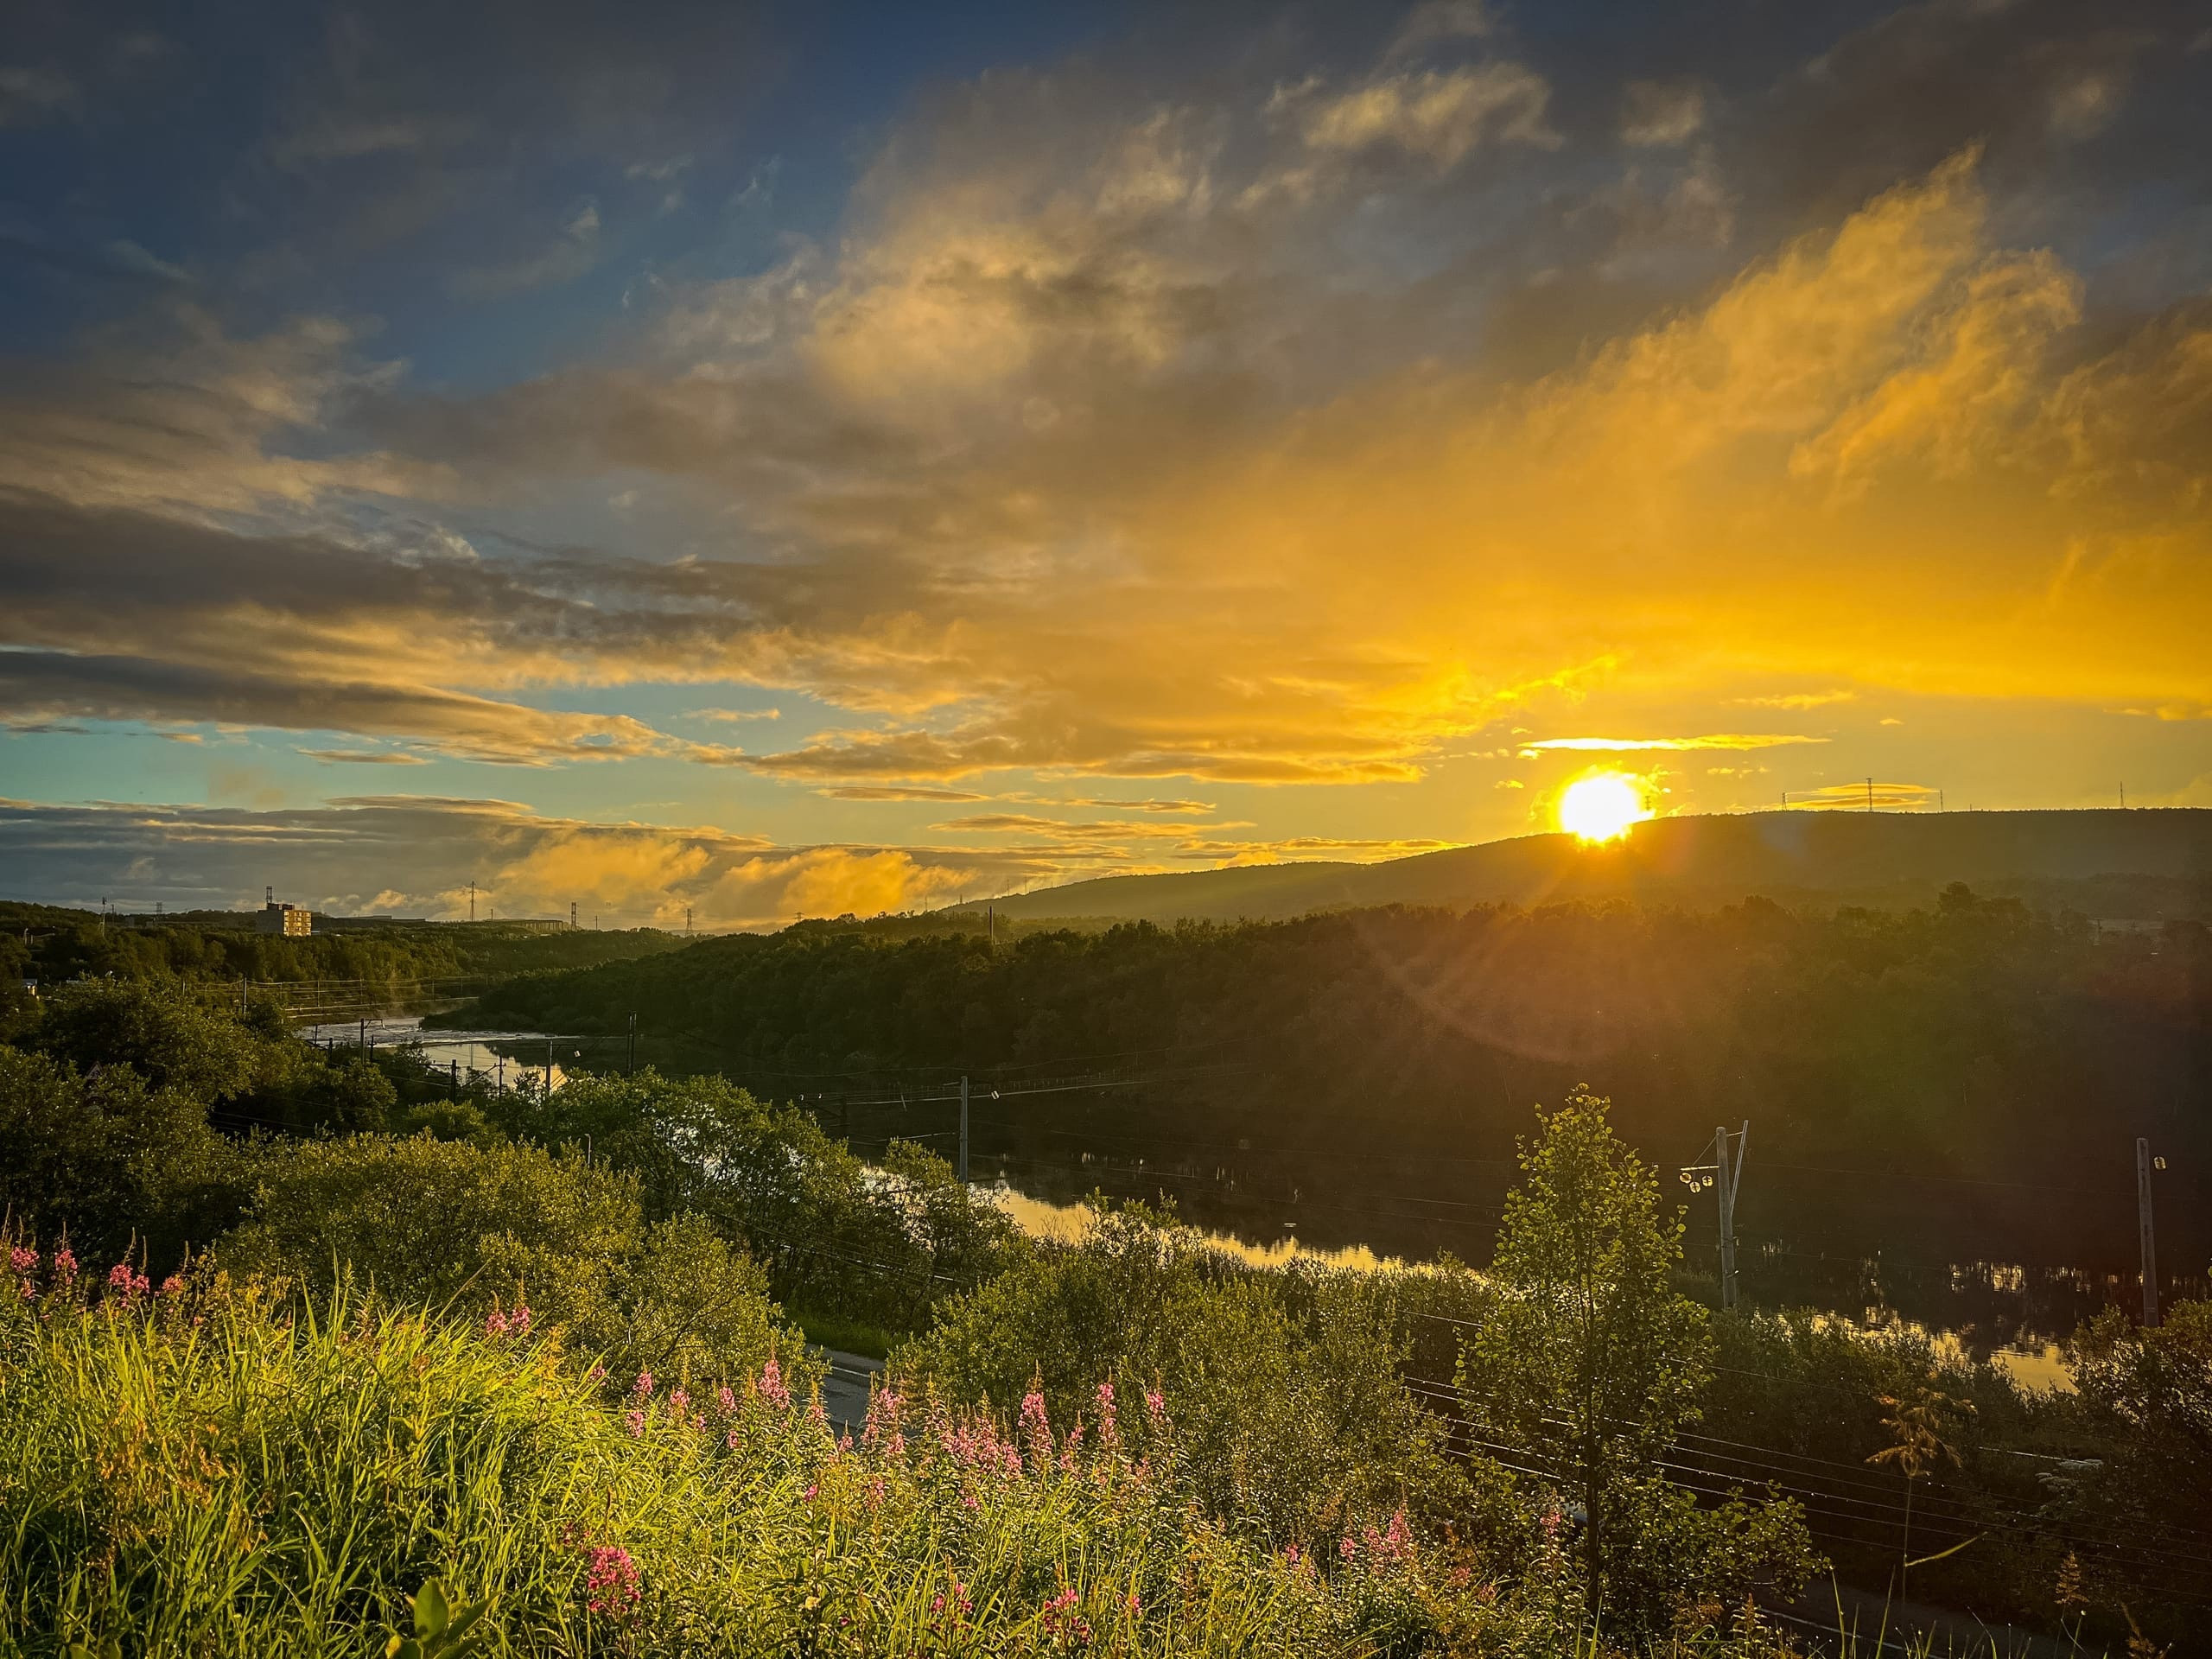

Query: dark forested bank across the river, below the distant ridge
<box><xmin>469</xmin><ymin>887</ymin><xmax>2212</xmax><ymax>1268</ymax></box>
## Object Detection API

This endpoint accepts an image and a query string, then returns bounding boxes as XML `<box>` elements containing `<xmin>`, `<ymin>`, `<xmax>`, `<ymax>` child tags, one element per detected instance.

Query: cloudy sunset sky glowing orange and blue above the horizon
<box><xmin>0</xmin><ymin>0</ymin><xmax>2212</xmax><ymax>927</ymax></box>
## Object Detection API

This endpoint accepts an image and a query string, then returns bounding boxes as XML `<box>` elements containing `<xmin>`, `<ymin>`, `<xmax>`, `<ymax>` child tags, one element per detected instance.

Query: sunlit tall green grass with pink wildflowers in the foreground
<box><xmin>0</xmin><ymin>1248</ymin><xmax>2070</xmax><ymax>1659</ymax></box>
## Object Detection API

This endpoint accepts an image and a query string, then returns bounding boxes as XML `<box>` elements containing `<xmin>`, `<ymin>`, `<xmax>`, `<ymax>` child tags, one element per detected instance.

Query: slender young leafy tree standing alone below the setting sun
<box><xmin>1462</xmin><ymin>1089</ymin><xmax>1712</xmax><ymax>1611</ymax></box>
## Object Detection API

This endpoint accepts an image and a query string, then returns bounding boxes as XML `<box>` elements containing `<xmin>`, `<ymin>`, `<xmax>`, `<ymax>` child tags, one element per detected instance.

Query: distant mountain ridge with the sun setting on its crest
<box><xmin>956</xmin><ymin>807</ymin><xmax>2212</xmax><ymax>923</ymax></box>
